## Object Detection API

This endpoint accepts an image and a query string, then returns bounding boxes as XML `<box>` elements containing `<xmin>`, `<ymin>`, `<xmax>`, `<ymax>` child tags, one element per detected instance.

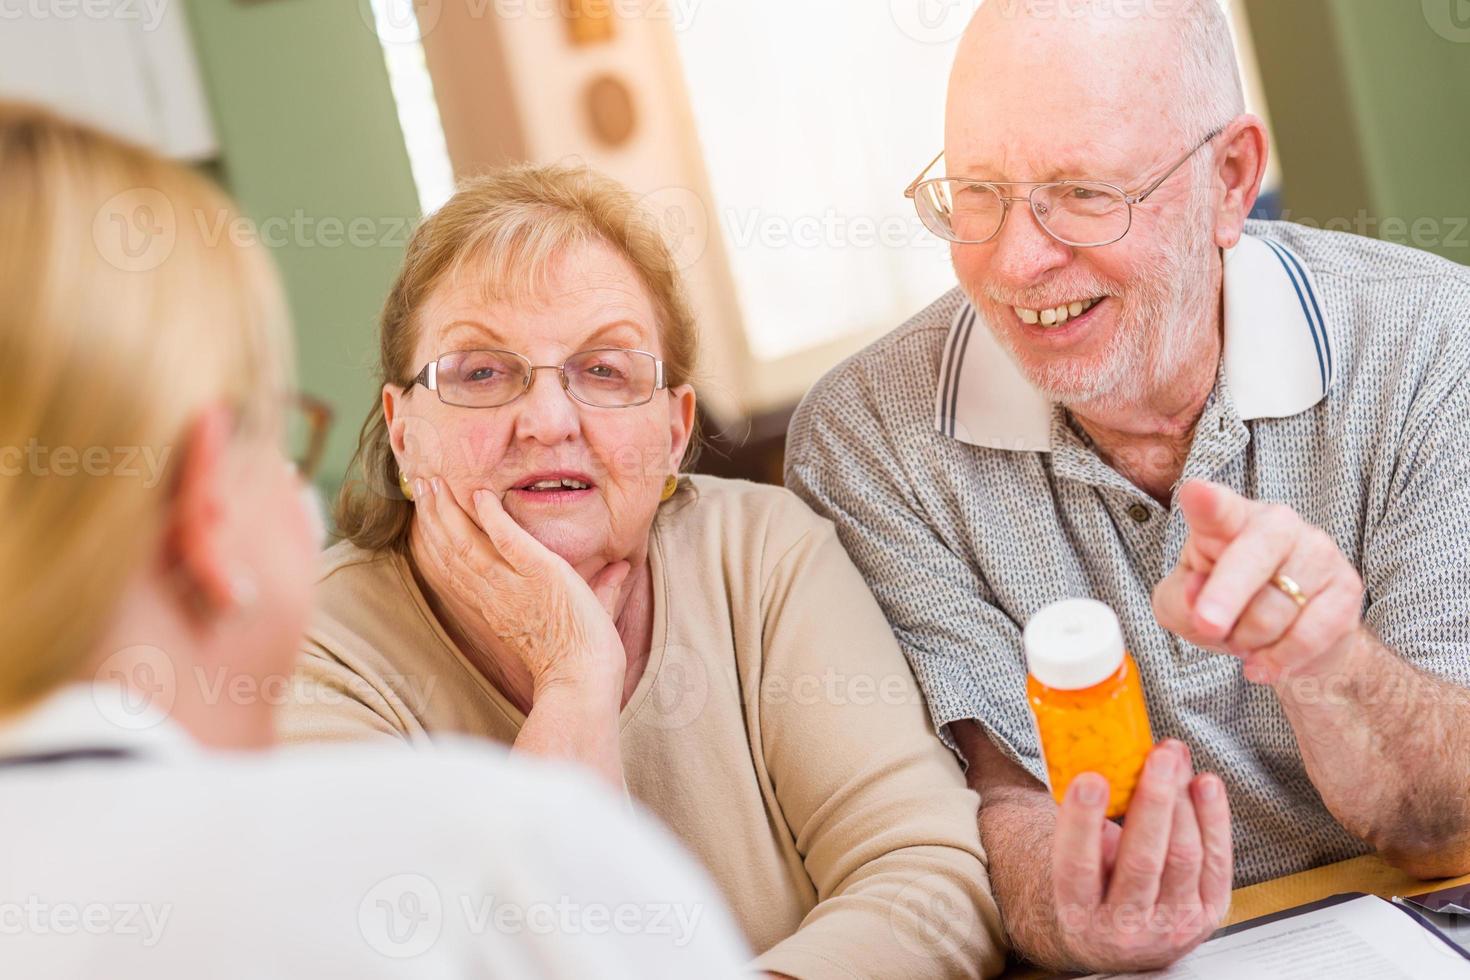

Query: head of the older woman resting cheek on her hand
<box><xmin>338</xmin><ymin>166</ymin><xmax>697</xmax><ymax>572</ymax></box>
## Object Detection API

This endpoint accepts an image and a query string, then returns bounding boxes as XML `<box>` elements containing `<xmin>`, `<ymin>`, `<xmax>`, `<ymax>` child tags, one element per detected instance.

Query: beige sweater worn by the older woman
<box><xmin>284</xmin><ymin>478</ymin><xmax>1004</xmax><ymax>980</ymax></box>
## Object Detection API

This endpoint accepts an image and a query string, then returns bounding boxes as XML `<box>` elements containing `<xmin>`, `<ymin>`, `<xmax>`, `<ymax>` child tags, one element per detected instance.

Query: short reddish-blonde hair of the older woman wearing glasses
<box><xmin>335</xmin><ymin>166</ymin><xmax>698</xmax><ymax>551</ymax></box>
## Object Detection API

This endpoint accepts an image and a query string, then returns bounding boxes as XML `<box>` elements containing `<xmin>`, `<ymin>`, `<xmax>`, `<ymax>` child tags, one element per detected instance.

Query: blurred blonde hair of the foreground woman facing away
<box><xmin>0</xmin><ymin>101</ymin><xmax>290</xmax><ymax>716</ymax></box>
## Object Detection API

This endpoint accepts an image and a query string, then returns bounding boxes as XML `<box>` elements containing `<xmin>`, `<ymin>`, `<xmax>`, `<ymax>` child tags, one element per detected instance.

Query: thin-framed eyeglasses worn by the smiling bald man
<box><xmin>904</xmin><ymin>126</ymin><xmax>1226</xmax><ymax>248</ymax></box>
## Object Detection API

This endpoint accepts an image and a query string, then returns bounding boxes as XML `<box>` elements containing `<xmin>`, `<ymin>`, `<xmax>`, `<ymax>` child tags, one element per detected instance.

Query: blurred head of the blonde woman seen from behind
<box><xmin>0</xmin><ymin>101</ymin><xmax>320</xmax><ymax>740</ymax></box>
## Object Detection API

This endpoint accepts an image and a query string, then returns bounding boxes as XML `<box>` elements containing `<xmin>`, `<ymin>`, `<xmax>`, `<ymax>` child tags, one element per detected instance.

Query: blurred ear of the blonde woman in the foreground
<box><xmin>165</xmin><ymin>406</ymin><xmax>235</xmax><ymax>610</ymax></box>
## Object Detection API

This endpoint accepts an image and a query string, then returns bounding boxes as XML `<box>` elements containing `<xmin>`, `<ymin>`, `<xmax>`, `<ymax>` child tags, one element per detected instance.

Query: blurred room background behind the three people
<box><xmin>0</xmin><ymin>0</ymin><xmax>1470</xmax><ymax>505</ymax></box>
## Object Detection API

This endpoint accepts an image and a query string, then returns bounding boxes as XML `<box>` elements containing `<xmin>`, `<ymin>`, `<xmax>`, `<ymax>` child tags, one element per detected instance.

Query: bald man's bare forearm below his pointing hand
<box><xmin>1276</xmin><ymin>629</ymin><xmax>1470</xmax><ymax>877</ymax></box>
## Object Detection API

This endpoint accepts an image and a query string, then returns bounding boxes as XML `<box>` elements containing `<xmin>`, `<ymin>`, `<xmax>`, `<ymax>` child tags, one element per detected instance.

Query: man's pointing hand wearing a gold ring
<box><xmin>1154</xmin><ymin>480</ymin><xmax>1363</xmax><ymax>683</ymax></box>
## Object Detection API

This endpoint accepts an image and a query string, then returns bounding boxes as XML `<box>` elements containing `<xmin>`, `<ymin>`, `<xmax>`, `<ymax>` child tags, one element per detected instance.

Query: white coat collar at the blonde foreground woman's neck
<box><xmin>0</xmin><ymin>682</ymin><xmax>198</xmax><ymax>757</ymax></box>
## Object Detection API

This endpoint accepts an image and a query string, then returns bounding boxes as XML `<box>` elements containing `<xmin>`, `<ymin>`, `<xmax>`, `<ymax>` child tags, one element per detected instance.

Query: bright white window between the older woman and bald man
<box><xmin>678</xmin><ymin>0</ymin><xmax>967</xmax><ymax>361</ymax></box>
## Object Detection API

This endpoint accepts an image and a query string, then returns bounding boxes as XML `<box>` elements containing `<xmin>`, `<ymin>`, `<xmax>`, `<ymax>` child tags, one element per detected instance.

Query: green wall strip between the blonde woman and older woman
<box><xmin>188</xmin><ymin>0</ymin><xmax>419</xmax><ymax>489</ymax></box>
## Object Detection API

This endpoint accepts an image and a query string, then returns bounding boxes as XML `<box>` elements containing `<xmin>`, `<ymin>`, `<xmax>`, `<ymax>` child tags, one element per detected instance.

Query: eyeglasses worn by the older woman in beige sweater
<box><xmin>407</xmin><ymin>347</ymin><xmax>669</xmax><ymax>408</ymax></box>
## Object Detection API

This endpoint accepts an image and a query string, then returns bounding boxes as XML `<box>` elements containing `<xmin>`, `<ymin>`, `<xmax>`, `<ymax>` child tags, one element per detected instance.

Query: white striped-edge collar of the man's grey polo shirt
<box><xmin>935</xmin><ymin>235</ymin><xmax>1333</xmax><ymax>453</ymax></box>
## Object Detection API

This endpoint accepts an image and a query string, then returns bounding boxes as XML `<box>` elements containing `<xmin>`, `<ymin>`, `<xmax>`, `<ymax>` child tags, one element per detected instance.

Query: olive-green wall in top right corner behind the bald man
<box><xmin>1247</xmin><ymin>0</ymin><xmax>1470</xmax><ymax>264</ymax></box>
